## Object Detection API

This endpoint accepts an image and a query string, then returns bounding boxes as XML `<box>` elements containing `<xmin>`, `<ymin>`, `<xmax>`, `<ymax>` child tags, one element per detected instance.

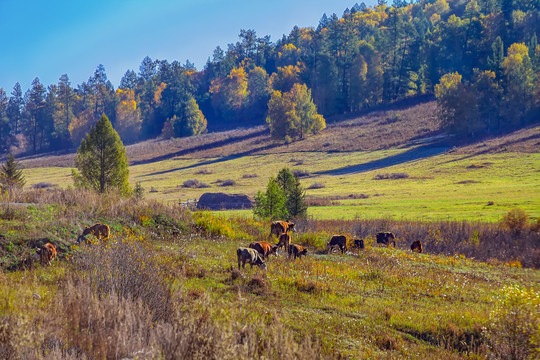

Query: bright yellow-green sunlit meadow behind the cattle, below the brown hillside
<box><xmin>25</xmin><ymin>147</ymin><xmax>540</xmax><ymax>222</ymax></box>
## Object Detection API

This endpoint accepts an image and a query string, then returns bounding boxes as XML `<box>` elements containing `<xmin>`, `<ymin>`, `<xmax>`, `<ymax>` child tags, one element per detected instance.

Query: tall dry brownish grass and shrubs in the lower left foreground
<box><xmin>0</xmin><ymin>233</ymin><xmax>328</xmax><ymax>359</ymax></box>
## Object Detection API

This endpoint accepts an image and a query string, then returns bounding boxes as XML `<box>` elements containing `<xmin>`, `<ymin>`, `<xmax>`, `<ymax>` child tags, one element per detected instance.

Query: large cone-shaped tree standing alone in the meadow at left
<box><xmin>72</xmin><ymin>115</ymin><xmax>130</xmax><ymax>195</ymax></box>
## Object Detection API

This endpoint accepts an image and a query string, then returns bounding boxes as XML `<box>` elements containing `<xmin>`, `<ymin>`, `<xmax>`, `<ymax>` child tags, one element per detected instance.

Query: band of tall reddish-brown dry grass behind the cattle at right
<box><xmin>295</xmin><ymin>218</ymin><xmax>540</xmax><ymax>268</ymax></box>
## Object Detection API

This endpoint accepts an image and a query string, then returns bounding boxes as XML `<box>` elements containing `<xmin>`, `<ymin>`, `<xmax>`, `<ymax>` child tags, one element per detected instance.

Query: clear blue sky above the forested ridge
<box><xmin>0</xmin><ymin>0</ymin><xmax>374</xmax><ymax>94</ymax></box>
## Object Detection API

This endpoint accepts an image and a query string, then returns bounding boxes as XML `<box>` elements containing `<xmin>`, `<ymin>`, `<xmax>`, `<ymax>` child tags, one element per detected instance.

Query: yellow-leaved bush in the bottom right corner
<box><xmin>484</xmin><ymin>285</ymin><xmax>540</xmax><ymax>360</ymax></box>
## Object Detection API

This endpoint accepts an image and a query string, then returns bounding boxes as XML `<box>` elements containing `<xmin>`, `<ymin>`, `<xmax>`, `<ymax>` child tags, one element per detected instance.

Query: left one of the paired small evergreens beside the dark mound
<box><xmin>253</xmin><ymin>177</ymin><xmax>289</xmax><ymax>220</ymax></box>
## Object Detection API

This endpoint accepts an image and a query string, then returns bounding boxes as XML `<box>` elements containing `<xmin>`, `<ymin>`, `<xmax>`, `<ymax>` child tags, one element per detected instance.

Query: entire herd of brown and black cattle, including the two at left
<box><xmin>36</xmin><ymin>221</ymin><xmax>423</xmax><ymax>269</ymax></box>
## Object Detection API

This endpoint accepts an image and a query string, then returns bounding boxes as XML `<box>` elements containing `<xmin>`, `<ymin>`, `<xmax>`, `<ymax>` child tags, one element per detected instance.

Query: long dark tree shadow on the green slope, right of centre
<box><xmin>313</xmin><ymin>144</ymin><xmax>449</xmax><ymax>175</ymax></box>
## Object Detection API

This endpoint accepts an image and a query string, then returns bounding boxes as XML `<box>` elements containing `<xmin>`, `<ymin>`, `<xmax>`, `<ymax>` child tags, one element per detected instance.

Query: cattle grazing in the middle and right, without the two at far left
<box><xmin>236</xmin><ymin>221</ymin><xmax>423</xmax><ymax>270</ymax></box>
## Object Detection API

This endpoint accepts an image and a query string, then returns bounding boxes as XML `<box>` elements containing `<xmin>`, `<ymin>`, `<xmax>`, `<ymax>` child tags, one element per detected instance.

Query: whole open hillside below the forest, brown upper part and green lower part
<box><xmin>20</xmin><ymin>102</ymin><xmax>540</xmax><ymax>222</ymax></box>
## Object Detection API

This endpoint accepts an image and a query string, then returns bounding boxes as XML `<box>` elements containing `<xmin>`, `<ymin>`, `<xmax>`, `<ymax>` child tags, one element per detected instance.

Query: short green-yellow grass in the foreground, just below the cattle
<box><xmin>170</xmin><ymin>239</ymin><xmax>540</xmax><ymax>359</ymax></box>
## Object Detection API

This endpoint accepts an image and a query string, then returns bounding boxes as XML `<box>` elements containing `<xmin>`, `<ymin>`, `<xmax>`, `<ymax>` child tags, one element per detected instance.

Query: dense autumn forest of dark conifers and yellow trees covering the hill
<box><xmin>0</xmin><ymin>0</ymin><xmax>540</xmax><ymax>153</ymax></box>
